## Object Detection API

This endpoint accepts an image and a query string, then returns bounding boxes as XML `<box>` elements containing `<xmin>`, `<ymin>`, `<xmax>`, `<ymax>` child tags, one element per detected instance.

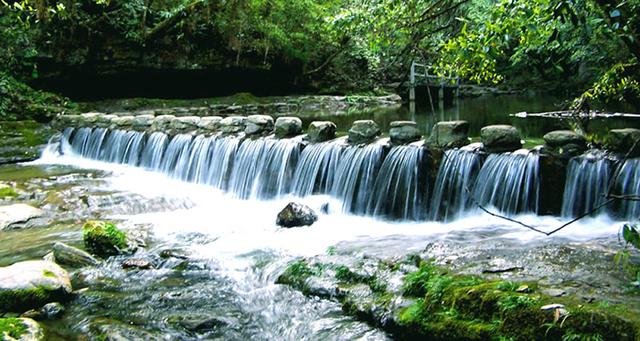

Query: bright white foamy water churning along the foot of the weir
<box><xmin>35</xmin><ymin>145</ymin><xmax>622</xmax><ymax>258</ymax></box>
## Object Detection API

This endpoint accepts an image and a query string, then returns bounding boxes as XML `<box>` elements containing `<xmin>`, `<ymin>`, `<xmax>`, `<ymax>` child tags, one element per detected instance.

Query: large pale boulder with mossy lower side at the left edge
<box><xmin>0</xmin><ymin>260</ymin><xmax>72</xmax><ymax>312</ymax></box>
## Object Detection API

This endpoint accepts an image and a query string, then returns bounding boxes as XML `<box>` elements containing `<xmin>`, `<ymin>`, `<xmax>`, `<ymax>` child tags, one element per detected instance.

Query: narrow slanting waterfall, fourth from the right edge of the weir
<box><xmin>429</xmin><ymin>148</ymin><xmax>482</xmax><ymax>221</ymax></box>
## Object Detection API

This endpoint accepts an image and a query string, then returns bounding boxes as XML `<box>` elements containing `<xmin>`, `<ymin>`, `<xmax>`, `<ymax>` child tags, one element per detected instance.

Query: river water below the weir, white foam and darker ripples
<box><xmin>0</xmin><ymin>94</ymin><xmax>636</xmax><ymax>340</ymax></box>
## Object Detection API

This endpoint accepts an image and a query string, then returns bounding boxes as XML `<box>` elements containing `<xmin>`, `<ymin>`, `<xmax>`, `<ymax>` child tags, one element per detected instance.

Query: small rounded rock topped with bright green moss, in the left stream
<box><xmin>82</xmin><ymin>221</ymin><xmax>129</xmax><ymax>257</ymax></box>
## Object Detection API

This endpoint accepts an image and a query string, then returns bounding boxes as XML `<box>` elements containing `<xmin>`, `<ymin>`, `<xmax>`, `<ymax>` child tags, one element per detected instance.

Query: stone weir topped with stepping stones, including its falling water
<box><xmin>55</xmin><ymin>113</ymin><xmax>640</xmax><ymax>221</ymax></box>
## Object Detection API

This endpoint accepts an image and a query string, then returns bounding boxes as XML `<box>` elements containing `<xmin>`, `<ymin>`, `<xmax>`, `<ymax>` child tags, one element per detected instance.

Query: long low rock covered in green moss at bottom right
<box><xmin>278</xmin><ymin>257</ymin><xmax>640</xmax><ymax>340</ymax></box>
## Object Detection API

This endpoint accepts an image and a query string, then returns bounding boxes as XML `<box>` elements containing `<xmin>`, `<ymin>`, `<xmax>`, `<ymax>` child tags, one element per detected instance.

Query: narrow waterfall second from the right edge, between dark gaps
<box><xmin>562</xmin><ymin>155</ymin><xmax>611</xmax><ymax>218</ymax></box>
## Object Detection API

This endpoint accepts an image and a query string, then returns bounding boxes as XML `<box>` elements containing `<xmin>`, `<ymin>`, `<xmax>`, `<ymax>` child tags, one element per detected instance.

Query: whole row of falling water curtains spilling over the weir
<box><xmin>57</xmin><ymin>128</ymin><xmax>640</xmax><ymax>221</ymax></box>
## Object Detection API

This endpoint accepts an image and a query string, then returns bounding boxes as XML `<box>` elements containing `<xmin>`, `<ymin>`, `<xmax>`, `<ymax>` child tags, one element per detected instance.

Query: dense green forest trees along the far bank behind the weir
<box><xmin>0</xmin><ymin>0</ymin><xmax>640</xmax><ymax>118</ymax></box>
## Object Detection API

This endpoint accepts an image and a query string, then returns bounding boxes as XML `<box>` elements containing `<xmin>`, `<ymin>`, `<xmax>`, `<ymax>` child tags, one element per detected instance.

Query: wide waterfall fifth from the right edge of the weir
<box><xmin>367</xmin><ymin>145</ymin><xmax>429</xmax><ymax>220</ymax></box>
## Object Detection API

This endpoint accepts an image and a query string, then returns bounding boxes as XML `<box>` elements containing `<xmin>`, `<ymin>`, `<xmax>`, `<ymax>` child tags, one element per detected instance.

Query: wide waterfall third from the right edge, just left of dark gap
<box><xmin>473</xmin><ymin>150</ymin><xmax>540</xmax><ymax>214</ymax></box>
